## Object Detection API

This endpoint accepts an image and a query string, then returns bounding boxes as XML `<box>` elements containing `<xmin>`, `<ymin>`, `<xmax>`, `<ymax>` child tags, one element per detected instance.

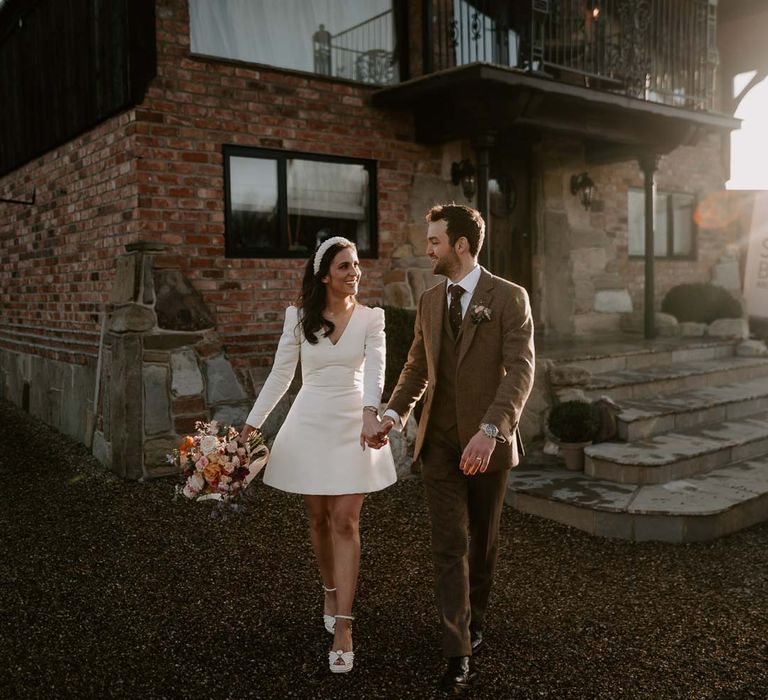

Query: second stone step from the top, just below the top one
<box><xmin>584</xmin><ymin>357</ymin><xmax>768</xmax><ymax>402</ymax></box>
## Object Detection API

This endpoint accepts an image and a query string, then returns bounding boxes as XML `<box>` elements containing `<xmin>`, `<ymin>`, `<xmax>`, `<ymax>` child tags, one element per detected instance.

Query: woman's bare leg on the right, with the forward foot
<box><xmin>328</xmin><ymin>494</ymin><xmax>365</xmax><ymax>651</ymax></box>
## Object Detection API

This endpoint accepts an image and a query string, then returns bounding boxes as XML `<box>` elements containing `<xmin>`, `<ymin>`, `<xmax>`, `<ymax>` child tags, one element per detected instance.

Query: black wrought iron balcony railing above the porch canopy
<box><xmin>424</xmin><ymin>0</ymin><xmax>718</xmax><ymax>109</ymax></box>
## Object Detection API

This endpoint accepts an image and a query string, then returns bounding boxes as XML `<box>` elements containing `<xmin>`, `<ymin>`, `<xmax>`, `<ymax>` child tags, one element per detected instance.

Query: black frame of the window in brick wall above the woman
<box><xmin>222</xmin><ymin>144</ymin><xmax>379</xmax><ymax>260</ymax></box>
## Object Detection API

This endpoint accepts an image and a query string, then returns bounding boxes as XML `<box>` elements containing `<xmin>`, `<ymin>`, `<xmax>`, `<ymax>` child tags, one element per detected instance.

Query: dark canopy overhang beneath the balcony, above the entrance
<box><xmin>372</xmin><ymin>63</ymin><xmax>741</xmax><ymax>157</ymax></box>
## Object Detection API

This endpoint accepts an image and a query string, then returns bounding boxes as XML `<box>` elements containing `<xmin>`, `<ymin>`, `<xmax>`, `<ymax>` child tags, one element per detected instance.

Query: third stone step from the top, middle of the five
<box><xmin>618</xmin><ymin>377</ymin><xmax>768</xmax><ymax>441</ymax></box>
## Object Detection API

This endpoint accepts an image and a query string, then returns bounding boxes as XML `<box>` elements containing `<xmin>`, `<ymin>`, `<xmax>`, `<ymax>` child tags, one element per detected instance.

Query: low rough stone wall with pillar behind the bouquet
<box><xmin>93</xmin><ymin>243</ymin><xmax>251</xmax><ymax>479</ymax></box>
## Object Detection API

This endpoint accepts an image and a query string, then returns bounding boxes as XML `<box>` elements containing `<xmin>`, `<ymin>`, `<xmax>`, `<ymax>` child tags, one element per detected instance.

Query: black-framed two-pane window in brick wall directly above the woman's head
<box><xmin>224</xmin><ymin>146</ymin><xmax>378</xmax><ymax>258</ymax></box>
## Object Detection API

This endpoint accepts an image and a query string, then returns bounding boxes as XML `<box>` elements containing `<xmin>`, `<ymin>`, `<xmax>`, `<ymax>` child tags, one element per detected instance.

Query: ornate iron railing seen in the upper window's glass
<box><xmin>312</xmin><ymin>10</ymin><xmax>398</xmax><ymax>85</ymax></box>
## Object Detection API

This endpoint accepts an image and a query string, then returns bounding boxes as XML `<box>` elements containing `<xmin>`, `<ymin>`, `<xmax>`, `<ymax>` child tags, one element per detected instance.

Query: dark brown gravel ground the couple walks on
<box><xmin>0</xmin><ymin>402</ymin><xmax>768</xmax><ymax>700</ymax></box>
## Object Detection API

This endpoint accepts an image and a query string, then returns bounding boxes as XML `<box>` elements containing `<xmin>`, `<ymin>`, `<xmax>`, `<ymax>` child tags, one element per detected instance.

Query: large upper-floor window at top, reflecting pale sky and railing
<box><xmin>189</xmin><ymin>0</ymin><xmax>398</xmax><ymax>85</ymax></box>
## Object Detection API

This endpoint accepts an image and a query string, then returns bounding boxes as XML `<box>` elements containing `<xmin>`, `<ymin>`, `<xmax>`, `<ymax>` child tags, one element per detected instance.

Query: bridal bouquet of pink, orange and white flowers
<box><xmin>168</xmin><ymin>421</ymin><xmax>269</xmax><ymax>510</ymax></box>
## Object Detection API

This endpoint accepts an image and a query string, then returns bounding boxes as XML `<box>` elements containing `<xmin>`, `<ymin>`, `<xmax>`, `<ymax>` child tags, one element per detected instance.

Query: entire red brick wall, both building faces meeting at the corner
<box><xmin>0</xmin><ymin>0</ymin><xmax>432</xmax><ymax>386</ymax></box>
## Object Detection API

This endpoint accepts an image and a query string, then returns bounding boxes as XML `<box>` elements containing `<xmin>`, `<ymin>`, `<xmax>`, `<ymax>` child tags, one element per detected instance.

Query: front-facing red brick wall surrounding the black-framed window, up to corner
<box><xmin>136</xmin><ymin>0</ymin><xmax>429</xmax><ymax>378</ymax></box>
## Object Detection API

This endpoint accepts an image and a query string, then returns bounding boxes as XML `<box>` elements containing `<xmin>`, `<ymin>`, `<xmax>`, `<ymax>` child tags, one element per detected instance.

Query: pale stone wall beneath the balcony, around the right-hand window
<box><xmin>530</xmin><ymin>136</ymin><xmax>743</xmax><ymax>336</ymax></box>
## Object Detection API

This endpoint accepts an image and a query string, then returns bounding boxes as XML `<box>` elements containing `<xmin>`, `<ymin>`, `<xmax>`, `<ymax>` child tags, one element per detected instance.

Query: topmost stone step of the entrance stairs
<box><xmin>560</xmin><ymin>338</ymin><xmax>740</xmax><ymax>374</ymax></box>
